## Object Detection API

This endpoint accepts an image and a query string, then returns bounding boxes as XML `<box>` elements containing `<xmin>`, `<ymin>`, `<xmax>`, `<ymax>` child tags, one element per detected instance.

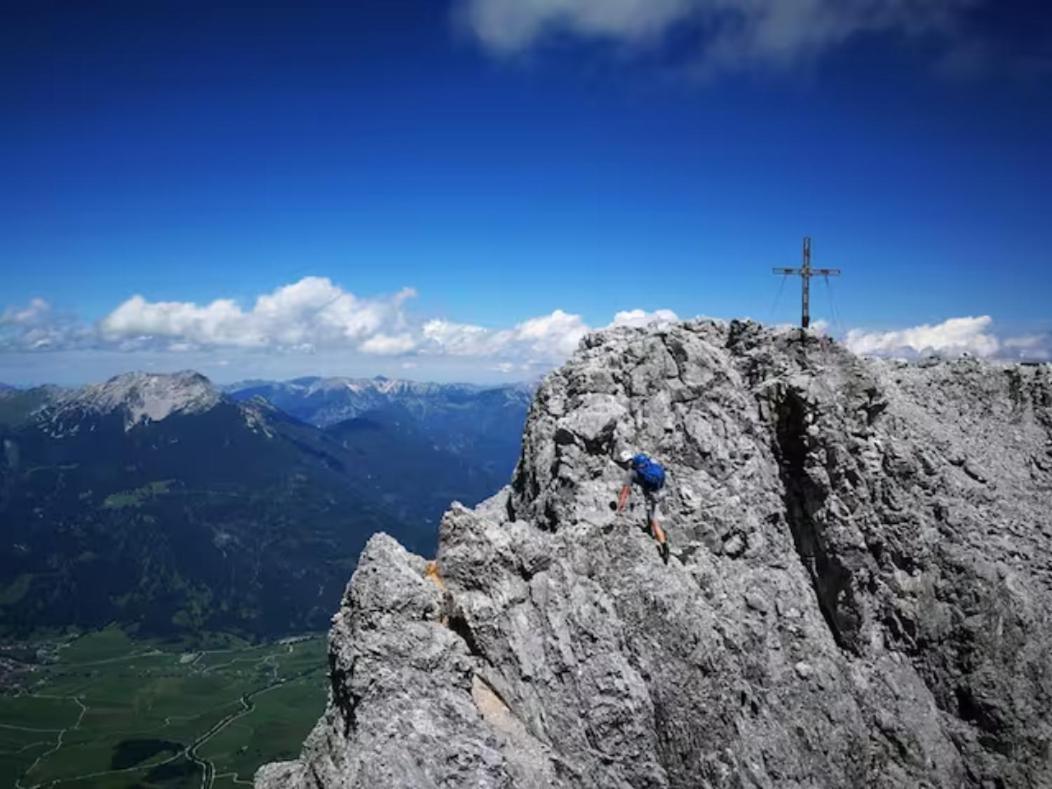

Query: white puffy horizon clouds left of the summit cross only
<box><xmin>0</xmin><ymin>277</ymin><xmax>676</xmax><ymax>372</ymax></box>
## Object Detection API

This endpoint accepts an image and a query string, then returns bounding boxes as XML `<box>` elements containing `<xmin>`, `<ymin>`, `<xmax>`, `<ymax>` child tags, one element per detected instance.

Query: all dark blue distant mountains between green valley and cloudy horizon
<box><xmin>0</xmin><ymin>372</ymin><xmax>529</xmax><ymax>635</ymax></box>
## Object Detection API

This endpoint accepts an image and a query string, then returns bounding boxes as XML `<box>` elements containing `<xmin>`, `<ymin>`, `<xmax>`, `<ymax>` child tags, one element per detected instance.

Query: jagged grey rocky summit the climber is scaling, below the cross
<box><xmin>256</xmin><ymin>321</ymin><xmax>1052</xmax><ymax>789</ymax></box>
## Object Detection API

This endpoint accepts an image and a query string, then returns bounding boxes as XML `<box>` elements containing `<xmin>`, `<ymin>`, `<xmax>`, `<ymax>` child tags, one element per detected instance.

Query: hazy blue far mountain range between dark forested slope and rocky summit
<box><xmin>224</xmin><ymin>376</ymin><xmax>533</xmax><ymax>552</ymax></box>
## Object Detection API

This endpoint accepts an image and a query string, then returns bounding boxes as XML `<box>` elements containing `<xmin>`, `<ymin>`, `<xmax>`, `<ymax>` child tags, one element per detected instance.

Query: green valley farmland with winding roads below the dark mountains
<box><xmin>0</xmin><ymin>628</ymin><xmax>327</xmax><ymax>789</ymax></box>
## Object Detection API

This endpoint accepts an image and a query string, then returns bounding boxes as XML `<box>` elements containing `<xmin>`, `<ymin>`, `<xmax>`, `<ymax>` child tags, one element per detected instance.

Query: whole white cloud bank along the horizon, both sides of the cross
<box><xmin>0</xmin><ymin>277</ymin><xmax>1052</xmax><ymax>377</ymax></box>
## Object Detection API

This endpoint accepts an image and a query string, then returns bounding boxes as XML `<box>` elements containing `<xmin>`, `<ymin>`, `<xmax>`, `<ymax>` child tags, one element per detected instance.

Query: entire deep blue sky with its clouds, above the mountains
<box><xmin>0</xmin><ymin>0</ymin><xmax>1052</xmax><ymax>384</ymax></box>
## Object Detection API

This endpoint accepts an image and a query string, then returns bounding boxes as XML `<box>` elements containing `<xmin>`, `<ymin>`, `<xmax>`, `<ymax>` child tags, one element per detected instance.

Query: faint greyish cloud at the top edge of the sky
<box><xmin>459</xmin><ymin>0</ymin><xmax>977</xmax><ymax>69</ymax></box>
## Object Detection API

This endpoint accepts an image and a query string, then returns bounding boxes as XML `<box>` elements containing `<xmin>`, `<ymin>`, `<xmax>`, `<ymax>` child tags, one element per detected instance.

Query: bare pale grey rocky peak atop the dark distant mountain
<box><xmin>58</xmin><ymin>370</ymin><xmax>222</xmax><ymax>429</ymax></box>
